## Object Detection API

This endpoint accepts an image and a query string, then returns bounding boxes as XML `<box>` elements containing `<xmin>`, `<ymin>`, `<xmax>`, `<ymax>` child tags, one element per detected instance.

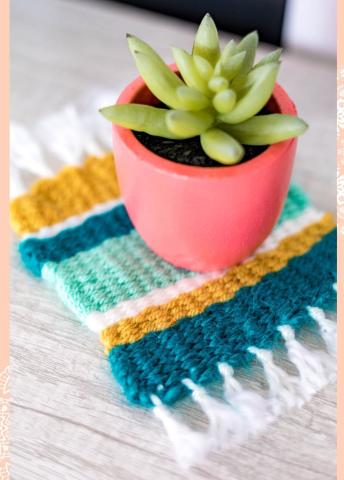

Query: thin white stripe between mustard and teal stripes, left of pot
<box><xmin>23</xmin><ymin>199</ymin><xmax>123</xmax><ymax>240</ymax></box>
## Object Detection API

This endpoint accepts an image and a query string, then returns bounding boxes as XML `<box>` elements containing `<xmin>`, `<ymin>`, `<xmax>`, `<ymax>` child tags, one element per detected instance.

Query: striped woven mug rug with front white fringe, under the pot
<box><xmin>11</xmin><ymin>97</ymin><xmax>336</xmax><ymax>466</ymax></box>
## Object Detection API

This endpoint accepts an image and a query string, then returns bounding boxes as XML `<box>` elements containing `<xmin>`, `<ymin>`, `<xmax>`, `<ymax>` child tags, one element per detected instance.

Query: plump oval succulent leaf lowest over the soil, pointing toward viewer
<box><xmin>201</xmin><ymin>128</ymin><xmax>244</xmax><ymax>165</ymax></box>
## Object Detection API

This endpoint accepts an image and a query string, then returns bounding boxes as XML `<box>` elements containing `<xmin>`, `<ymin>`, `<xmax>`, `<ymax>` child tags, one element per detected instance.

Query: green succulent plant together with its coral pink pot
<box><xmin>101</xmin><ymin>14</ymin><xmax>307</xmax><ymax>271</ymax></box>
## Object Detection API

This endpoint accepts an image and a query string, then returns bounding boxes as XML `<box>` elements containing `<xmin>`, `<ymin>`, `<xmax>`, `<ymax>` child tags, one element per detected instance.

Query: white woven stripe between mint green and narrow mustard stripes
<box><xmin>84</xmin><ymin>207</ymin><xmax>323</xmax><ymax>332</ymax></box>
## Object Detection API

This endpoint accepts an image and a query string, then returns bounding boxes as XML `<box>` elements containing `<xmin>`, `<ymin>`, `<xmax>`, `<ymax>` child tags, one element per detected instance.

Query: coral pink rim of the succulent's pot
<box><xmin>112</xmin><ymin>64</ymin><xmax>297</xmax><ymax>178</ymax></box>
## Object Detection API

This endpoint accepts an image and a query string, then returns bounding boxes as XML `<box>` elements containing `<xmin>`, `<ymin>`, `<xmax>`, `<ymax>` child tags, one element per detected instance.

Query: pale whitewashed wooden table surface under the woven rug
<box><xmin>11</xmin><ymin>0</ymin><xmax>336</xmax><ymax>480</ymax></box>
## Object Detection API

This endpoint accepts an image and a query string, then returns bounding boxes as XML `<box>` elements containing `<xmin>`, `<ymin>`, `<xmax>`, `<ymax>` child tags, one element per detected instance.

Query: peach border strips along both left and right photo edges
<box><xmin>0</xmin><ymin>0</ymin><xmax>344</xmax><ymax>480</ymax></box>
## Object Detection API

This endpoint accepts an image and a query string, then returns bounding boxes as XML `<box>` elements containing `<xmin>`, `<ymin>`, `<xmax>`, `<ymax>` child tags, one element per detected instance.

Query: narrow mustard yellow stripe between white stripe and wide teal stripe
<box><xmin>101</xmin><ymin>214</ymin><xmax>335</xmax><ymax>352</ymax></box>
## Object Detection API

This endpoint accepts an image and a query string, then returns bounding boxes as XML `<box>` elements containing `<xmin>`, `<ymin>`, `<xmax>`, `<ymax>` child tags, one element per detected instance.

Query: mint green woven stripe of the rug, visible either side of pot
<box><xmin>42</xmin><ymin>185</ymin><xmax>309</xmax><ymax>318</ymax></box>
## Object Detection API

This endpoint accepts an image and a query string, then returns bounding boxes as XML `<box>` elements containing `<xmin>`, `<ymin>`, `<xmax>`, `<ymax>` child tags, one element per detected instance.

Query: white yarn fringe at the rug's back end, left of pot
<box><xmin>10</xmin><ymin>89</ymin><xmax>118</xmax><ymax>198</ymax></box>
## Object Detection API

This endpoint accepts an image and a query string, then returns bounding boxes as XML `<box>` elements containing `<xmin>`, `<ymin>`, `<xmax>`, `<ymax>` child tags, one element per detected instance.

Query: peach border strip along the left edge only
<box><xmin>0</xmin><ymin>0</ymin><xmax>10</xmax><ymax>480</ymax></box>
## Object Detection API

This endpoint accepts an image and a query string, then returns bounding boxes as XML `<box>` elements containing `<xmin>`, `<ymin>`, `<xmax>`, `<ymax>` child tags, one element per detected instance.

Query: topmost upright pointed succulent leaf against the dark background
<box><xmin>192</xmin><ymin>13</ymin><xmax>220</xmax><ymax>65</ymax></box>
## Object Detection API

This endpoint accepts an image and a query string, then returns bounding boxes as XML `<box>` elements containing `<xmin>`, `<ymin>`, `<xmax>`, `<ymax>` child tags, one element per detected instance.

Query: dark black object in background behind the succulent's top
<box><xmin>109</xmin><ymin>0</ymin><xmax>287</xmax><ymax>45</ymax></box>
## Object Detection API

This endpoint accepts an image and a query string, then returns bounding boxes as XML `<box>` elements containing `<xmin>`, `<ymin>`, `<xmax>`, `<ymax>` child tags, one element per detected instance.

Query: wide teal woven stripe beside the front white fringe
<box><xmin>109</xmin><ymin>230</ymin><xmax>337</xmax><ymax>407</ymax></box>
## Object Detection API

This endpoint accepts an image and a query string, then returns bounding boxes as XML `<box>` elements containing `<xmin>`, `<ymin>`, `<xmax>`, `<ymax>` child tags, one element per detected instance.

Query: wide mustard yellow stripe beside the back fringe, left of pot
<box><xmin>10</xmin><ymin>153</ymin><xmax>119</xmax><ymax>235</ymax></box>
